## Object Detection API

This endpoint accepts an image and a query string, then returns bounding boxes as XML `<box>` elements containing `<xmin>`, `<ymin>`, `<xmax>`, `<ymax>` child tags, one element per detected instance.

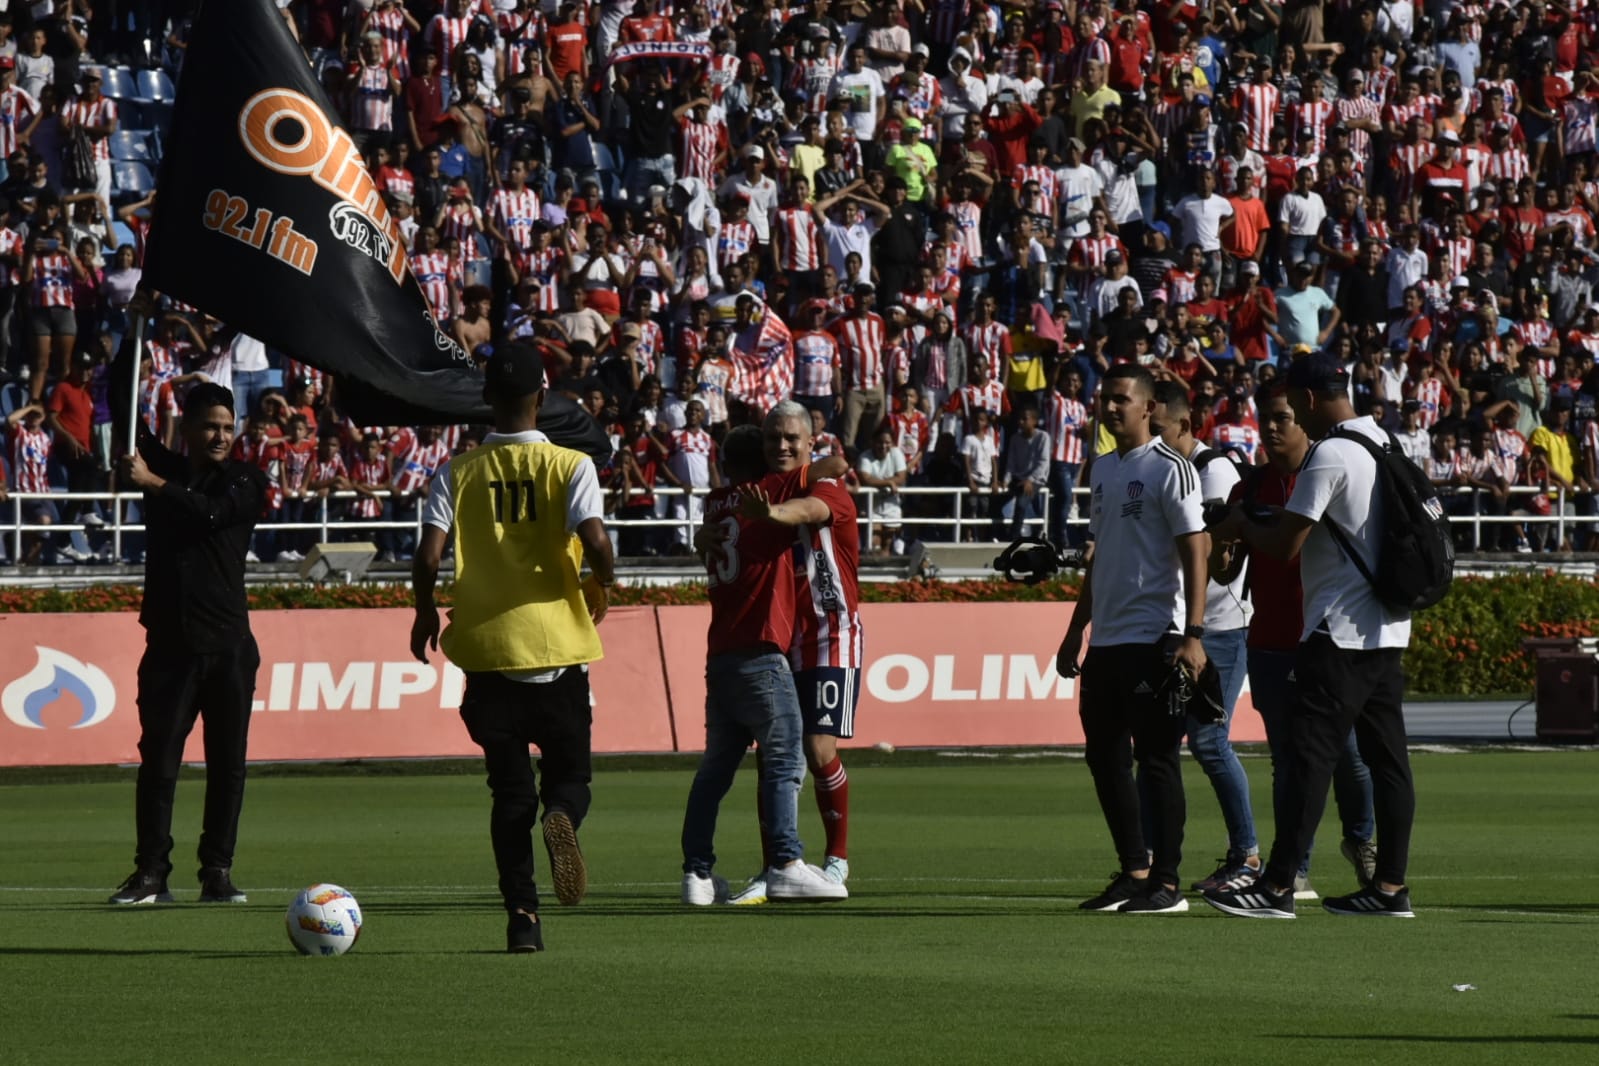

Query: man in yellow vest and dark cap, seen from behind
<box><xmin>411</xmin><ymin>342</ymin><xmax>616</xmax><ymax>953</ymax></box>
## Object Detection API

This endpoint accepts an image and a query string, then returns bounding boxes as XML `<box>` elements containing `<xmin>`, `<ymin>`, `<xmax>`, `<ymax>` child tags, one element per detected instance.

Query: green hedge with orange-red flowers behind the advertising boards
<box><xmin>0</xmin><ymin>571</ymin><xmax>1599</xmax><ymax>697</ymax></box>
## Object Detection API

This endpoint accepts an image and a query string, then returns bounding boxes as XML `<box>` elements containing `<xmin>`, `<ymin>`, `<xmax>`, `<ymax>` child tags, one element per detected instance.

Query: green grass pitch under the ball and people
<box><xmin>0</xmin><ymin>751</ymin><xmax>1599</xmax><ymax>1066</ymax></box>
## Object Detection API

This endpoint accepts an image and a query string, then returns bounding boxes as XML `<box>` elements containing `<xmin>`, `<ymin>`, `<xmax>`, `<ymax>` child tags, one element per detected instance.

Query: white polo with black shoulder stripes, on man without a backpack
<box><xmin>1089</xmin><ymin>436</ymin><xmax>1204</xmax><ymax>647</ymax></box>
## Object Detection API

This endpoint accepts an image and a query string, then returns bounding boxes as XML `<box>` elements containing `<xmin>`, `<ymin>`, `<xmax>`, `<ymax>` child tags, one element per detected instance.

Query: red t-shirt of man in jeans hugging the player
<box><xmin>705</xmin><ymin>467</ymin><xmax>807</xmax><ymax>655</ymax></box>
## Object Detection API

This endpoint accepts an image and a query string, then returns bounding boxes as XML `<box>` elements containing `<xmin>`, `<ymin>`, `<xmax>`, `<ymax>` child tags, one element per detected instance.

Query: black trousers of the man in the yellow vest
<box><xmin>461</xmin><ymin>666</ymin><xmax>593</xmax><ymax>911</ymax></box>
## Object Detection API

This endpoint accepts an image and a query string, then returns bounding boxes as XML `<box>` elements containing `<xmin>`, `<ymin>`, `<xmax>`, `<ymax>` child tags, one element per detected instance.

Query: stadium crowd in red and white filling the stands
<box><xmin>0</xmin><ymin>0</ymin><xmax>1599</xmax><ymax>561</ymax></box>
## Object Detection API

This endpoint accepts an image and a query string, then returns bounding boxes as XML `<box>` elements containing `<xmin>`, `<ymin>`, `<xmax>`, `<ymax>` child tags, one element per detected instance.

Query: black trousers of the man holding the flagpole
<box><xmin>134</xmin><ymin>636</ymin><xmax>261</xmax><ymax>874</ymax></box>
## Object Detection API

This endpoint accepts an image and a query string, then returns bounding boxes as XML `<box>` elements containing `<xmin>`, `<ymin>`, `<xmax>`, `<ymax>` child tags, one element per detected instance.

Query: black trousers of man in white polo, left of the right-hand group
<box><xmin>1078</xmin><ymin>644</ymin><xmax>1188</xmax><ymax>884</ymax></box>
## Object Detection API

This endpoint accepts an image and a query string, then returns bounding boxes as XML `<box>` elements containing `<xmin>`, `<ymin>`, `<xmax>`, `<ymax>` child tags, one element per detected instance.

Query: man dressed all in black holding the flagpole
<box><xmin>110</xmin><ymin>382</ymin><xmax>267</xmax><ymax>905</ymax></box>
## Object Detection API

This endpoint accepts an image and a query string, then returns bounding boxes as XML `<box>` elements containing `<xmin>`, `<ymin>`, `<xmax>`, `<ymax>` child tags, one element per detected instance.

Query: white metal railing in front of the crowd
<box><xmin>0</xmin><ymin>486</ymin><xmax>1573</xmax><ymax>563</ymax></box>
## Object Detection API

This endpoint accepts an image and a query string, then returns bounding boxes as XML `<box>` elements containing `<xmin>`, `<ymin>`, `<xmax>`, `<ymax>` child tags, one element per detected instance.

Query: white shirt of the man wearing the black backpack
<box><xmin>1287</xmin><ymin>417</ymin><xmax>1410</xmax><ymax>650</ymax></box>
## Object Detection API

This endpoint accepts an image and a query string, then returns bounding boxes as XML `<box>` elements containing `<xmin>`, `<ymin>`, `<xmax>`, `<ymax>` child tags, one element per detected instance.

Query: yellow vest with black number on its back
<box><xmin>440</xmin><ymin>441</ymin><xmax>603</xmax><ymax>671</ymax></box>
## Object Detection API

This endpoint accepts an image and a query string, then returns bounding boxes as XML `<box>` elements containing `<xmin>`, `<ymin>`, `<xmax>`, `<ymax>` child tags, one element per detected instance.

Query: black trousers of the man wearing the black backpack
<box><xmin>1266</xmin><ymin>633</ymin><xmax>1415</xmax><ymax>887</ymax></box>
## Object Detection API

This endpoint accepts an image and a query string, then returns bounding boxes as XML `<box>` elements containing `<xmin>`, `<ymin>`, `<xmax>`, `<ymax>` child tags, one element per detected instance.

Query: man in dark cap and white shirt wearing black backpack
<box><xmin>1204</xmin><ymin>353</ymin><xmax>1415</xmax><ymax>917</ymax></box>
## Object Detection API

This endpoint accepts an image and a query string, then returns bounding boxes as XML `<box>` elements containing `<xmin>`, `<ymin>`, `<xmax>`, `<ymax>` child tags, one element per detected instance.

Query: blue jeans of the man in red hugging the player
<box><xmin>683</xmin><ymin>649</ymin><xmax>804</xmax><ymax>874</ymax></box>
